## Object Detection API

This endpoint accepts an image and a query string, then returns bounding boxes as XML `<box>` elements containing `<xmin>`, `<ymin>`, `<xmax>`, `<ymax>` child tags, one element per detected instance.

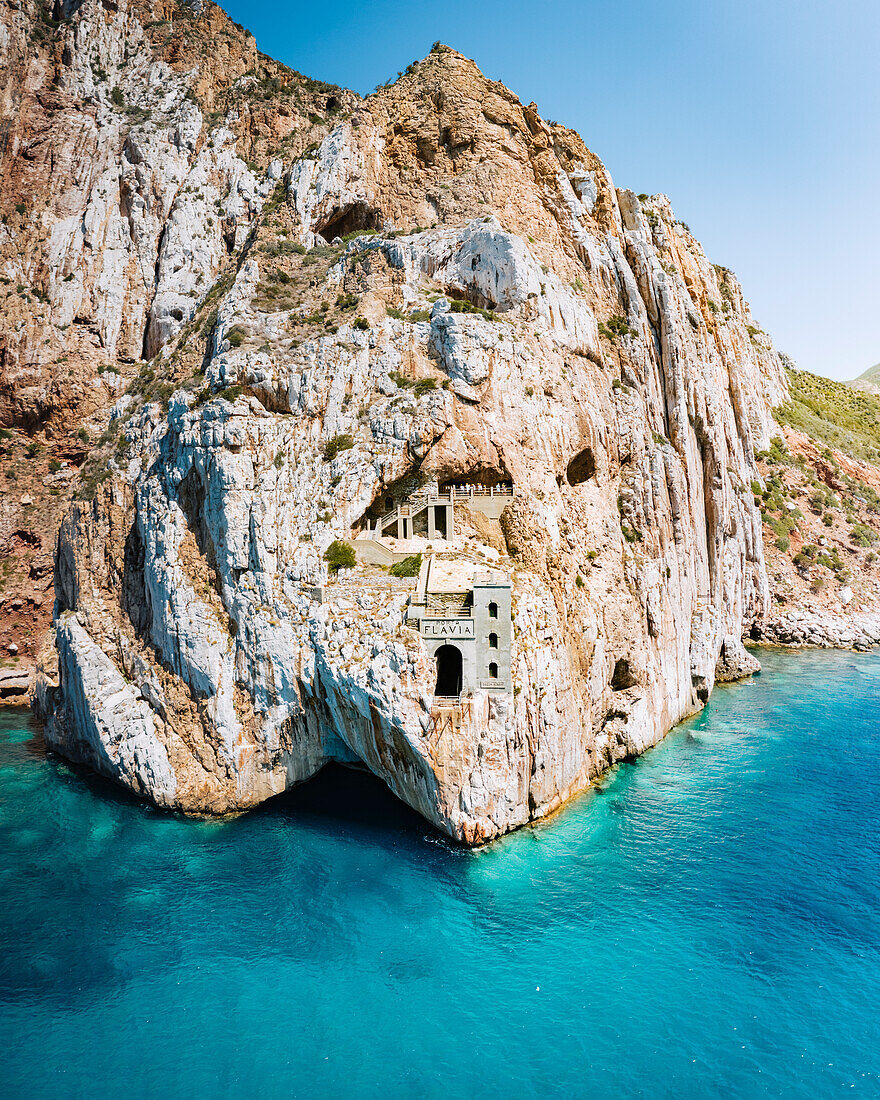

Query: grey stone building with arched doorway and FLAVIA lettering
<box><xmin>407</xmin><ymin>554</ymin><xmax>513</xmax><ymax>699</ymax></box>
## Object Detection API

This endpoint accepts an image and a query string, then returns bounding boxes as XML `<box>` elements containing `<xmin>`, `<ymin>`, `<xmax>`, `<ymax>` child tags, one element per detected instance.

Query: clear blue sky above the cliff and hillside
<box><xmin>222</xmin><ymin>0</ymin><xmax>880</xmax><ymax>378</ymax></box>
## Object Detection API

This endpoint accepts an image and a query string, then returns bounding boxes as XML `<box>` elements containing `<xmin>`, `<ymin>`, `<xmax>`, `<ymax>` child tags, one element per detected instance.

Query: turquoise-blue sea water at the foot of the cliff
<box><xmin>0</xmin><ymin>652</ymin><xmax>880</xmax><ymax>1100</ymax></box>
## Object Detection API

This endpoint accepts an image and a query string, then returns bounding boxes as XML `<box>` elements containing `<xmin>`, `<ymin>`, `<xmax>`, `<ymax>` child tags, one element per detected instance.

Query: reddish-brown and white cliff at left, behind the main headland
<box><xmin>0</xmin><ymin>0</ymin><xmax>356</xmax><ymax>660</ymax></box>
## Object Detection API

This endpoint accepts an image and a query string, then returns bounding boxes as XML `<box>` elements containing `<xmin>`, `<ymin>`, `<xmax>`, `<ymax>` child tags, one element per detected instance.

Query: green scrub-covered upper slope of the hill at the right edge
<box><xmin>774</xmin><ymin>371</ymin><xmax>880</xmax><ymax>465</ymax></box>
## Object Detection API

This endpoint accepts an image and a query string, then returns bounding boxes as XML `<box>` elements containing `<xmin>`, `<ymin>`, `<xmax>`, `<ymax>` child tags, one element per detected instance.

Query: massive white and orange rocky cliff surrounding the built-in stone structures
<box><xmin>2</xmin><ymin>2</ymin><xmax>787</xmax><ymax>843</ymax></box>
